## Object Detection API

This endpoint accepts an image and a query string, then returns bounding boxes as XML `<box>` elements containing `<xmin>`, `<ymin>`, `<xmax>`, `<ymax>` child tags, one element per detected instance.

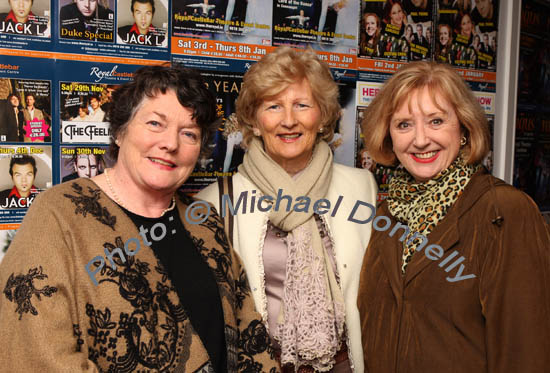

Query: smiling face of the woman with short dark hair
<box><xmin>116</xmin><ymin>90</ymin><xmax>201</xmax><ymax>193</ymax></box>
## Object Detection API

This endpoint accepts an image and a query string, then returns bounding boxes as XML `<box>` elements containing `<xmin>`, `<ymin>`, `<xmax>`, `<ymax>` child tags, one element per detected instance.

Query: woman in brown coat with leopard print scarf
<box><xmin>358</xmin><ymin>62</ymin><xmax>550</xmax><ymax>373</ymax></box>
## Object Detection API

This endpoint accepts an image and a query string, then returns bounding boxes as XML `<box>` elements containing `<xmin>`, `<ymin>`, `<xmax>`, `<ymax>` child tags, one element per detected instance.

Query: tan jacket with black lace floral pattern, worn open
<box><xmin>0</xmin><ymin>179</ymin><xmax>278</xmax><ymax>373</ymax></box>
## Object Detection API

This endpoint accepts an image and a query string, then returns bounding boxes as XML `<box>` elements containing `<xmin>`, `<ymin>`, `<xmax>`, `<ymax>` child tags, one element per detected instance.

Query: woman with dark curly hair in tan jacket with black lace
<box><xmin>0</xmin><ymin>66</ymin><xmax>277</xmax><ymax>373</ymax></box>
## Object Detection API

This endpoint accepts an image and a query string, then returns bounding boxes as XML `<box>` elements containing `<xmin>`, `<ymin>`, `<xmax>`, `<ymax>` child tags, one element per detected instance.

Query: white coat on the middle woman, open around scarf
<box><xmin>197</xmin><ymin>163</ymin><xmax>377</xmax><ymax>373</ymax></box>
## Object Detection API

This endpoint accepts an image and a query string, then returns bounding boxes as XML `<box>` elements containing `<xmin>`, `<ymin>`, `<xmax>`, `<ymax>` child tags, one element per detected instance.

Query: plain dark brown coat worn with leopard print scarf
<box><xmin>358</xmin><ymin>169</ymin><xmax>550</xmax><ymax>373</ymax></box>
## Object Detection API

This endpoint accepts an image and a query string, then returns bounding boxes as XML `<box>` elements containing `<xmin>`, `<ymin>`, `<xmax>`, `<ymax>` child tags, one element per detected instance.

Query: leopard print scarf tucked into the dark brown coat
<box><xmin>387</xmin><ymin>156</ymin><xmax>481</xmax><ymax>274</ymax></box>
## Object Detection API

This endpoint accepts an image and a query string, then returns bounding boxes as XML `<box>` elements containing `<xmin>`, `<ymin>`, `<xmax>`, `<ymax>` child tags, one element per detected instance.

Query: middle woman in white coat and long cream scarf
<box><xmin>202</xmin><ymin>47</ymin><xmax>376</xmax><ymax>372</ymax></box>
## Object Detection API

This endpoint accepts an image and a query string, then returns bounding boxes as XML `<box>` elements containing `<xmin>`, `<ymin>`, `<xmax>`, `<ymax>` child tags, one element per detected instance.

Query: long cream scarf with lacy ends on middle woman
<box><xmin>239</xmin><ymin>138</ymin><xmax>345</xmax><ymax>372</ymax></box>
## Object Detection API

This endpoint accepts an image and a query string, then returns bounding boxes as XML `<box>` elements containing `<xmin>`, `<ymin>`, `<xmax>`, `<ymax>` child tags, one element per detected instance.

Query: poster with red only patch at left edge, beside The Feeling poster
<box><xmin>0</xmin><ymin>78</ymin><xmax>52</xmax><ymax>143</ymax></box>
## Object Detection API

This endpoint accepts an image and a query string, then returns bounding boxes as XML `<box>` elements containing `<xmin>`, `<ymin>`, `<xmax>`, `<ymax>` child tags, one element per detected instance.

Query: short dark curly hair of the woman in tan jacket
<box><xmin>109</xmin><ymin>65</ymin><xmax>218</xmax><ymax>160</ymax></box>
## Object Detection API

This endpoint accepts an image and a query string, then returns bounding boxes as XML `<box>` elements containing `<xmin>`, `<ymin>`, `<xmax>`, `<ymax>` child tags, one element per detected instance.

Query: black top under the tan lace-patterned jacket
<box><xmin>122</xmin><ymin>207</ymin><xmax>227</xmax><ymax>373</ymax></box>
